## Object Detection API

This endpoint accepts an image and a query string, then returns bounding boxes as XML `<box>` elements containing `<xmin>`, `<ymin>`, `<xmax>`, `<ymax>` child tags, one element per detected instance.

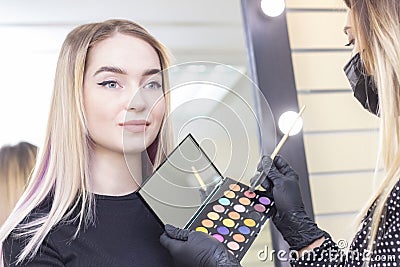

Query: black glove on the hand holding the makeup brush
<box><xmin>250</xmin><ymin>155</ymin><xmax>329</xmax><ymax>250</ymax></box>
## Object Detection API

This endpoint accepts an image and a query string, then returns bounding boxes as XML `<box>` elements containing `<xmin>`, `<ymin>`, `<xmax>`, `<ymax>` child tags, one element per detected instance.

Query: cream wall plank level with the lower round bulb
<box><xmin>298</xmin><ymin>92</ymin><xmax>379</xmax><ymax>132</ymax></box>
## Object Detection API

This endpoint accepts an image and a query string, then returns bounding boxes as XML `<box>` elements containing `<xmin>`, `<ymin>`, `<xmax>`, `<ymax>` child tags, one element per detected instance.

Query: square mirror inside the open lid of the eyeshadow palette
<box><xmin>139</xmin><ymin>134</ymin><xmax>223</xmax><ymax>228</ymax></box>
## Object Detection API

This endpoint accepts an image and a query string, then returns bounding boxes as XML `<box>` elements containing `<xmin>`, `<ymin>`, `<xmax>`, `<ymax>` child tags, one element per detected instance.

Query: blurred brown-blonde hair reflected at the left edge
<box><xmin>0</xmin><ymin>142</ymin><xmax>37</xmax><ymax>225</ymax></box>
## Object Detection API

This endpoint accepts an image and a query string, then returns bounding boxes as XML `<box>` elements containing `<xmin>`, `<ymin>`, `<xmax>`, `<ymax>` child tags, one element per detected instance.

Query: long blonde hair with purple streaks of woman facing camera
<box><xmin>0</xmin><ymin>19</ymin><xmax>170</xmax><ymax>262</ymax></box>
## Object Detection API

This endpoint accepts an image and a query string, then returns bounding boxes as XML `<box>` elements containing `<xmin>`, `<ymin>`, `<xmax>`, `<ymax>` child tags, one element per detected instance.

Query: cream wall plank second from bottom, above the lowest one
<box><xmin>310</xmin><ymin>172</ymin><xmax>374</xmax><ymax>215</ymax></box>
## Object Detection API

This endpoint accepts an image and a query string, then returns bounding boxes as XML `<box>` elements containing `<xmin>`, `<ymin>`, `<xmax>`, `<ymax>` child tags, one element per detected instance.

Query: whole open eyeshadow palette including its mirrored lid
<box><xmin>138</xmin><ymin>134</ymin><xmax>274</xmax><ymax>260</ymax></box>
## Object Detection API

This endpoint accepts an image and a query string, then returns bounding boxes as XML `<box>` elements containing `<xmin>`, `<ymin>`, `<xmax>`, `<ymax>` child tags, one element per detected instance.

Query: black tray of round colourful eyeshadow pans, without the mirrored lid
<box><xmin>187</xmin><ymin>178</ymin><xmax>274</xmax><ymax>260</ymax></box>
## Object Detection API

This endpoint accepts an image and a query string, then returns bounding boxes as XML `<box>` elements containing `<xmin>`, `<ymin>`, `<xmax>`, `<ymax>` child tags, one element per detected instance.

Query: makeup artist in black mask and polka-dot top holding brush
<box><xmin>253</xmin><ymin>0</ymin><xmax>400</xmax><ymax>267</ymax></box>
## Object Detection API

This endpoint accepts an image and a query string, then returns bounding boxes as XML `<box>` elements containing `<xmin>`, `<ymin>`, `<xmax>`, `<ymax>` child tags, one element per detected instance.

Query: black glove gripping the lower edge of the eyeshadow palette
<box><xmin>160</xmin><ymin>224</ymin><xmax>241</xmax><ymax>267</ymax></box>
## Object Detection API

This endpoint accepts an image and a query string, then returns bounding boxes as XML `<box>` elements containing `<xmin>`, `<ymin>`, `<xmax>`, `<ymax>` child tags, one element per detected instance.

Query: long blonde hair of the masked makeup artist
<box><xmin>345</xmin><ymin>0</ymin><xmax>400</xmax><ymax>258</ymax></box>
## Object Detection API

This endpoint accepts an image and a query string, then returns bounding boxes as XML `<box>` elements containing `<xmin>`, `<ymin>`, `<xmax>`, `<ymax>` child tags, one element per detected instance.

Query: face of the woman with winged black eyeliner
<box><xmin>83</xmin><ymin>33</ymin><xmax>165</xmax><ymax>153</ymax></box>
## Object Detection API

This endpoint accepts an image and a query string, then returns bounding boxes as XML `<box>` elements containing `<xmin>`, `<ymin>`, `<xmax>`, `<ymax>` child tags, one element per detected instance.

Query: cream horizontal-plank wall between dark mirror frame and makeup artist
<box><xmin>286</xmin><ymin>0</ymin><xmax>368</xmax><ymax>251</ymax></box>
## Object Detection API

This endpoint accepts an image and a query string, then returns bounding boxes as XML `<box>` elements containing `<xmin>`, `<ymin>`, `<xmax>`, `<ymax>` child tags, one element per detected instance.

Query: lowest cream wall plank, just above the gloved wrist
<box><xmin>315</xmin><ymin>213</ymin><xmax>358</xmax><ymax>244</ymax></box>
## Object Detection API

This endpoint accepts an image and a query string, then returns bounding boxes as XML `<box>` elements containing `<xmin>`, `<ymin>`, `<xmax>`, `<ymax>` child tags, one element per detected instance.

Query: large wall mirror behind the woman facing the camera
<box><xmin>0</xmin><ymin>0</ymin><xmax>275</xmax><ymax>266</ymax></box>
